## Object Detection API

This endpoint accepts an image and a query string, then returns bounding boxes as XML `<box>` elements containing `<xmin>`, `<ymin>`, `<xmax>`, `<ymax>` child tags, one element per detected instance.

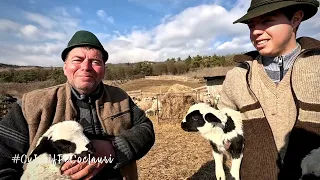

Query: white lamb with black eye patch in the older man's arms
<box><xmin>21</xmin><ymin>121</ymin><xmax>93</xmax><ymax>180</ymax></box>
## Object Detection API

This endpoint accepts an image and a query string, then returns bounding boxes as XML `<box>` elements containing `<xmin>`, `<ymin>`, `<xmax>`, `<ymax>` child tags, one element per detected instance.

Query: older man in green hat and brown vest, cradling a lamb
<box><xmin>0</xmin><ymin>31</ymin><xmax>155</xmax><ymax>179</ymax></box>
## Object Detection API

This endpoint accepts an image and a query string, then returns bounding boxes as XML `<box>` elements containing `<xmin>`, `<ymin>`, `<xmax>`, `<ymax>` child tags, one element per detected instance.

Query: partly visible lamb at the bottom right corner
<box><xmin>300</xmin><ymin>147</ymin><xmax>320</xmax><ymax>180</ymax></box>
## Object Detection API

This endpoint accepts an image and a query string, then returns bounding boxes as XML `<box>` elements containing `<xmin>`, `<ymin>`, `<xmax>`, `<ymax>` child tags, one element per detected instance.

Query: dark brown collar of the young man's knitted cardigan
<box><xmin>233</xmin><ymin>37</ymin><xmax>320</xmax><ymax>63</ymax></box>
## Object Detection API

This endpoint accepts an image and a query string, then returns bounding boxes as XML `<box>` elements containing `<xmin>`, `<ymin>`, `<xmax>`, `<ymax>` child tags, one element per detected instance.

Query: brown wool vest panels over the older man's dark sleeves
<box><xmin>22</xmin><ymin>83</ymin><xmax>138</xmax><ymax>179</ymax></box>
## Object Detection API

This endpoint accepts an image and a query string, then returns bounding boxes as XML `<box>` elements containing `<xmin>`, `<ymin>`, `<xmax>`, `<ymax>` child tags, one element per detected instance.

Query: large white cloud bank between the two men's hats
<box><xmin>105</xmin><ymin>1</ymin><xmax>252</xmax><ymax>63</ymax></box>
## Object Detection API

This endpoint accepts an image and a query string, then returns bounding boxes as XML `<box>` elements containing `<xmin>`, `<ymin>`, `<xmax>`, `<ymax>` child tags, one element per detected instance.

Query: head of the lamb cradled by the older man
<box><xmin>30</xmin><ymin>121</ymin><xmax>94</xmax><ymax>161</ymax></box>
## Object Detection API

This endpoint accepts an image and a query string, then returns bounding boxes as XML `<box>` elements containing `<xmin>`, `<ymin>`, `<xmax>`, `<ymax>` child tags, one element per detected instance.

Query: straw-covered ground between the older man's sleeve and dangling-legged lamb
<box><xmin>138</xmin><ymin>118</ymin><xmax>234</xmax><ymax>180</ymax></box>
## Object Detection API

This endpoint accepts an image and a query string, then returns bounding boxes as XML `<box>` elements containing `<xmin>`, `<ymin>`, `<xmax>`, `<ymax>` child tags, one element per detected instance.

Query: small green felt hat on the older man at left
<box><xmin>61</xmin><ymin>30</ymin><xmax>109</xmax><ymax>62</ymax></box>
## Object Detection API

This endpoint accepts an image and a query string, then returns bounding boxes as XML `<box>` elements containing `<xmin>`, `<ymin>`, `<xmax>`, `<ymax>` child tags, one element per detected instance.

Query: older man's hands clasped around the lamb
<box><xmin>61</xmin><ymin>140</ymin><xmax>115</xmax><ymax>180</ymax></box>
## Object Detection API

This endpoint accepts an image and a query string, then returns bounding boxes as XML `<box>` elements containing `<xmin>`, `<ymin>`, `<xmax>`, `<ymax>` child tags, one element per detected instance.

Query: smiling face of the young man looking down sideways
<box><xmin>248</xmin><ymin>11</ymin><xmax>299</xmax><ymax>56</ymax></box>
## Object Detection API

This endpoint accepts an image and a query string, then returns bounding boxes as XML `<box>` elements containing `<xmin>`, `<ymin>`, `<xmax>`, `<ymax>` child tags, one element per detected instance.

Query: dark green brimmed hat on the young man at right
<box><xmin>233</xmin><ymin>0</ymin><xmax>319</xmax><ymax>24</ymax></box>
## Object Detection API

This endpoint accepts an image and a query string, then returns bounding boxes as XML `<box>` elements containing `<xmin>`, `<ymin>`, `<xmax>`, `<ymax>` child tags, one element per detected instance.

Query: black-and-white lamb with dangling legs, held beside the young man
<box><xmin>181</xmin><ymin>103</ymin><xmax>244</xmax><ymax>180</ymax></box>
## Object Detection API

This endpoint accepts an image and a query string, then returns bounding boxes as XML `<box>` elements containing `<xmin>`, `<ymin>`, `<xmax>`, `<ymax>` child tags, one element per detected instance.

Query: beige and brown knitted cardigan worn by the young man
<box><xmin>218</xmin><ymin>37</ymin><xmax>320</xmax><ymax>180</ymax></box>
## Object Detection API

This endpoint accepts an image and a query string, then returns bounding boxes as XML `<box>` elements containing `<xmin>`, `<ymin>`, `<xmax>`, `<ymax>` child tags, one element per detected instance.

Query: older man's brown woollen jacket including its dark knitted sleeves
<box><xmin>0</xmin><ymin>84</ymin><xmax>155</xmax><ymax>179</ymax></box>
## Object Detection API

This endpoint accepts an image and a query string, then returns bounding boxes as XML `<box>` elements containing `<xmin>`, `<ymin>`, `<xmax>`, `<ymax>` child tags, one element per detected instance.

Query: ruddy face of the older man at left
<box><xmin>63</xmin><ymin>47</ymin><xmax>105</xmax><ymax>94</ymax></box>
